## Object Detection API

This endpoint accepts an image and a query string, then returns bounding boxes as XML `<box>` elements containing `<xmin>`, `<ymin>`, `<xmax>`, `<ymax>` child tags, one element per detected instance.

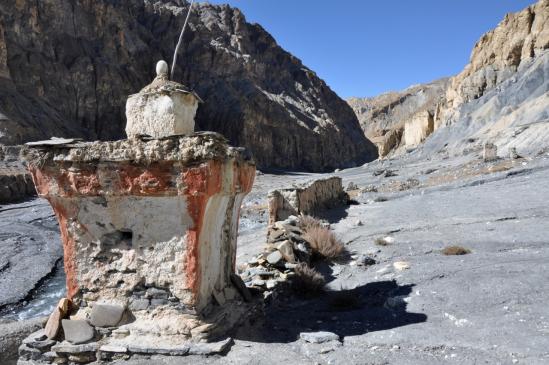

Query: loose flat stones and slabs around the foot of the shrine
<box><xmin>19</xmin><ymin>298</ymin><xmax>231</xmax><ymax>364</ymax></box>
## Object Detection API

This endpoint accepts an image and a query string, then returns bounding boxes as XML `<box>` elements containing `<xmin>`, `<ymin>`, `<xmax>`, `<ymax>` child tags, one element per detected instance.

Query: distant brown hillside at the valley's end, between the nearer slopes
<box><xmin>348</xmin><ymin>78</ymin><xmax>448</xmax><ymax>156</ymax></box>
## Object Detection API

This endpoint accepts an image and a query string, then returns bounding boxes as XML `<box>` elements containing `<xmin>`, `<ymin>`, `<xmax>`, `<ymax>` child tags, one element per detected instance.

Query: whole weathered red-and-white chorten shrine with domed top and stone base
<box><xmin>19</xmin><ymin>61</ymin><xmax>255</xmax><ymax>364</ymax></box>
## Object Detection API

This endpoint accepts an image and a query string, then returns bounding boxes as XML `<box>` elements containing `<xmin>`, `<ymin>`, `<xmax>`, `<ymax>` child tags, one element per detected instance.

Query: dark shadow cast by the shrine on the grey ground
<box><xmin>233</xmin><ymin>281</ymin><xmax>427</xmax><ymax>343</ymax></box>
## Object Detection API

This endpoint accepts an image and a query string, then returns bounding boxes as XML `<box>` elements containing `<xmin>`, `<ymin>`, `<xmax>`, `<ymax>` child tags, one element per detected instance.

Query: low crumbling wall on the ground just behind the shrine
<box><xmin>269</xmin><ymin>176</ymin><xmax>349</xmax><ymax>225</ymax></box>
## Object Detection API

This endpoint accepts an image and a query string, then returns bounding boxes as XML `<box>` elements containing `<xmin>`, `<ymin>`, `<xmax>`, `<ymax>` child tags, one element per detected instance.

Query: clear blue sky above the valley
<box><xmin>209</xmin><ymin>0</ymin><xmax>535</xmax><ymax>98</ymax></box>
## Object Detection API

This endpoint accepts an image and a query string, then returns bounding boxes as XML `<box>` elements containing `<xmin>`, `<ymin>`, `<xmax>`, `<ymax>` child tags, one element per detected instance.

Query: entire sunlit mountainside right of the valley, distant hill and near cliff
<box><xmin>349</xmin><ymin>0</ymin><xmax>549</xmax><ymax>159</ymax></box>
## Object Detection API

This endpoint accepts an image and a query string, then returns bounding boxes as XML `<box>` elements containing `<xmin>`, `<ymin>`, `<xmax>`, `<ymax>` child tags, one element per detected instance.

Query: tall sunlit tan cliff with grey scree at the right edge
<box><xmin>423</xmin><ymin>0</ymin><xmax>549</xmax><ymax>157</ymax></box>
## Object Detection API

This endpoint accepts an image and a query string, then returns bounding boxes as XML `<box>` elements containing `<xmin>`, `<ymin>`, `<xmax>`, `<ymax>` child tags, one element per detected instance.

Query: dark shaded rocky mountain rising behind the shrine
<box><xmin>0</xmin><ymin>0</ymin><xmax>377</xmax><ymax>171</ymax></box>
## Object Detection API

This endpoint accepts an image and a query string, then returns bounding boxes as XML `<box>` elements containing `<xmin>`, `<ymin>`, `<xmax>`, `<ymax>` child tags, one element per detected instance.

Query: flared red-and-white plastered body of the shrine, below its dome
<box><xmin>25</xmin><ymin>133</ymin><xmax>255</xmax><ymax>335</ymax></box>
